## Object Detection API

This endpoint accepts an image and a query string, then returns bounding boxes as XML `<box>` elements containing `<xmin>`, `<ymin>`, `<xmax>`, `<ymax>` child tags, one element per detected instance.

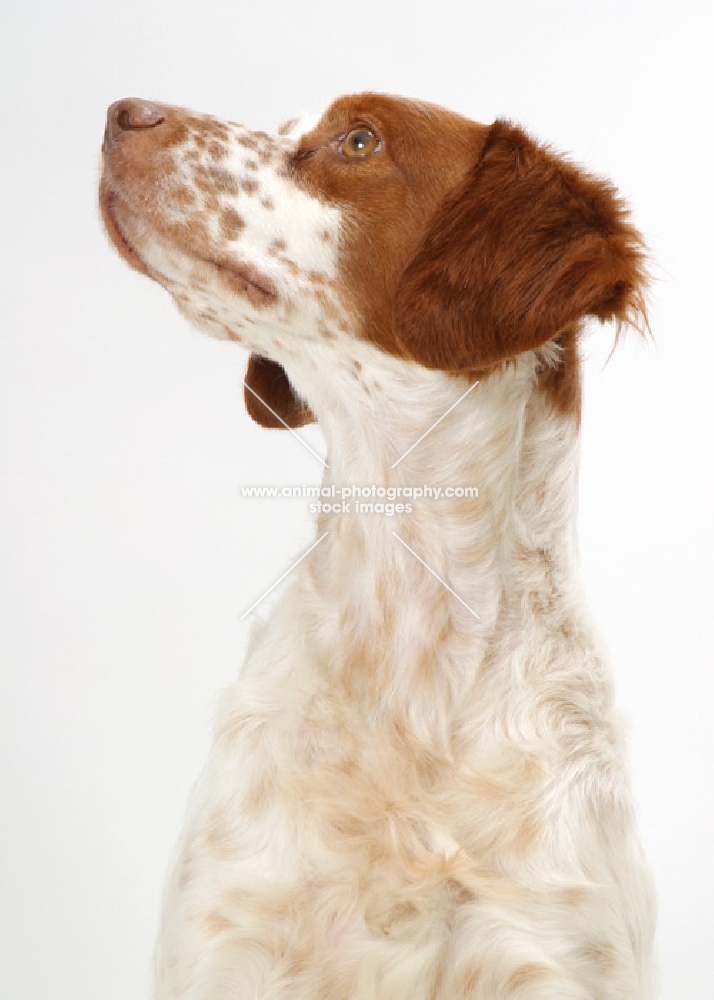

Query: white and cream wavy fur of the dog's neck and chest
<box><xmin>153</xmin><ymin>355</ymin><xmax>651</xmax><ymax>1000</ymax></box>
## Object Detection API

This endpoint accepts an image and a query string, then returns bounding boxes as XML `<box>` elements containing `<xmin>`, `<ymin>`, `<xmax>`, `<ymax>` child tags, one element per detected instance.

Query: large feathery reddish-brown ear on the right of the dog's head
<box><xmin>395</xmin><ymin>121</ymin><xmax>647</xmax><ymax>370</ymax></box>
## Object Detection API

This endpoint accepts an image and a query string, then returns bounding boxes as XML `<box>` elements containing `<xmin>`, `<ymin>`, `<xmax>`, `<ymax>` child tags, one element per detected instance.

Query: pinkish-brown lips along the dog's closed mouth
<box><xmin>100</xmin><ymin>183</ymin><xmax>278</xmax><ymax>307</ymax></box>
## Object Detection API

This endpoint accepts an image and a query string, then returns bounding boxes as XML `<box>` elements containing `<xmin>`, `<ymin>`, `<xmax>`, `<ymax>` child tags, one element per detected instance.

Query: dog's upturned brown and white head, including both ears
<box><xmin>100</xmin><ymin>94</ymin><xmax>645</xmax><ymax>426</ymax></box>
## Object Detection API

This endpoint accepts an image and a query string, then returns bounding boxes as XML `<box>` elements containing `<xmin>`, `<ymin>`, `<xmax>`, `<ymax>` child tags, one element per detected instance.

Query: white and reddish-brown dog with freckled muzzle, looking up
<box><xmin>100</xmin><ymin>93</ymin><xmax>655</xmax><ymax>1000</ymax></box>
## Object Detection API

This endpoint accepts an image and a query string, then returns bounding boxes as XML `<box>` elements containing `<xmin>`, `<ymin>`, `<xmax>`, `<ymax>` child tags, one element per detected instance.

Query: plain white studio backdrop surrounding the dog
<box><xmin>0</xmin><ymin>0</ymin><xmax>714</xmax><ymax>1000</ymax></box>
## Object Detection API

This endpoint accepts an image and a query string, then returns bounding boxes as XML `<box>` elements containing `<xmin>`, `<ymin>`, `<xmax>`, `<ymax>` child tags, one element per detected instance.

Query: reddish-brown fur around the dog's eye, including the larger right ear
<box><xmin>292</xmin><ymin>94</ymin><xmax>646</xmax><ymax>413</ymax></box>
